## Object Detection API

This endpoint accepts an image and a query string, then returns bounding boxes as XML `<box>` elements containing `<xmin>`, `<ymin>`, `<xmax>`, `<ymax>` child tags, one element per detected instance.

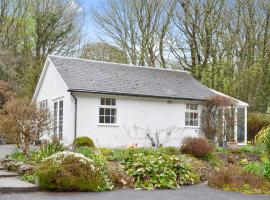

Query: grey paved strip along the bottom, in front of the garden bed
<box><xmin>0</xmin><ymin>184</ymin><xmax>270</xmax><ymax>200</ymax></box>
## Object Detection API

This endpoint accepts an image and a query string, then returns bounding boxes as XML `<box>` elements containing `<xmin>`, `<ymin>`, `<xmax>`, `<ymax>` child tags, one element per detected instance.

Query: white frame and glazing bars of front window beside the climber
<box><xmin>184</xmin><ymin>103</ymin><xmax>200</xmax><ymax>128</ymax></box>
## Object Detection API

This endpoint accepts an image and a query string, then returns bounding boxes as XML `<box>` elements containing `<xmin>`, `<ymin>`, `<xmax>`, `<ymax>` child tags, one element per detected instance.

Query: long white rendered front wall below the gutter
<box><xmin>75</xmin><ymin>93</ymin><xmax>201</xmax><ymax>147</ymax></box>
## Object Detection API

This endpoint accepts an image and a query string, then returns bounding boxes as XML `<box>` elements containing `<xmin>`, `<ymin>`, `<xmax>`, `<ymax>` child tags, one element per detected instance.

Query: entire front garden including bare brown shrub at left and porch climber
<box><xmin>0</xmin><ymin>98</ymin><xmax>270</xmax><ymax>194</ymax></box>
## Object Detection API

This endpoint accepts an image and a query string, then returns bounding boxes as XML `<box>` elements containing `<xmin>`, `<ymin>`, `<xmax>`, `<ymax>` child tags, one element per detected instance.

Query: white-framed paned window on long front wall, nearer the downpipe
<box><xmin>99</xmin><ymin>98</ymin><xmax>117</xmax><ymax>124</ymax></box>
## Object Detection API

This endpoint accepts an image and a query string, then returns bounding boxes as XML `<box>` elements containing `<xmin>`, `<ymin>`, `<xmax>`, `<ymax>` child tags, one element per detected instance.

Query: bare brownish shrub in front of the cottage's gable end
<box><xmin>0</xmin><ymin>99</ymin><xmax>51</xmax><ymax>155</ymax></box>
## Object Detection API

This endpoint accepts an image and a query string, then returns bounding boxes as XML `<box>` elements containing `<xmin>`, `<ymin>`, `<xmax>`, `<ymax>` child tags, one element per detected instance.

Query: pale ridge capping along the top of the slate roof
<box><xmin>48</xmin><ymin>54</ymin><xmax>189</xmax><ymax>74</ymax></box>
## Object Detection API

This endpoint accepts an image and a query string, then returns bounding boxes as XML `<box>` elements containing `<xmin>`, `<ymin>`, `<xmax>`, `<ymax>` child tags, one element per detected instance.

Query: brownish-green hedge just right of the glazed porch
<box><xmin>247</xmin><ymin>113</ymin><xmax>270</xmax><ymax>141</ymax></box>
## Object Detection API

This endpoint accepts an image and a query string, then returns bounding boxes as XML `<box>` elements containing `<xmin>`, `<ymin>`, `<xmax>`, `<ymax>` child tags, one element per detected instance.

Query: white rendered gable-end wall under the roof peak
<box><xmin>36</xmin><ymin>62</ymin><xmax>74</xmax><ymax>142</ymax></box>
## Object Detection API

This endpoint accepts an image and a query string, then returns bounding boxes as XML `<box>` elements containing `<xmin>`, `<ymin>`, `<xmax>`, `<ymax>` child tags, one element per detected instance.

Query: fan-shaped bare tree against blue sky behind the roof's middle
<box><xmin>92</xmin><ymin>0</ymin><xmax>175</xmax><ymax>67</ymax></box>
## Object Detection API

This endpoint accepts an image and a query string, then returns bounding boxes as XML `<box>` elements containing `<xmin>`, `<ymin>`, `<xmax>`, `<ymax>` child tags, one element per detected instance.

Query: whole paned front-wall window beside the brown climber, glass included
<box><xmin>185</xmin><ymin>104</ymin><xmax>199</xmax><ymax>126</ymax></box>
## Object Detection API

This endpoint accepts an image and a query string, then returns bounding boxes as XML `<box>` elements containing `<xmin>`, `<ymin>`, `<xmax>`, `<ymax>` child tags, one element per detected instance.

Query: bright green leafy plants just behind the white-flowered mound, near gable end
<box><xmin>34</xmin><ymin>141</ymin><xmax>66</xmax><ymax>162</ymax></box>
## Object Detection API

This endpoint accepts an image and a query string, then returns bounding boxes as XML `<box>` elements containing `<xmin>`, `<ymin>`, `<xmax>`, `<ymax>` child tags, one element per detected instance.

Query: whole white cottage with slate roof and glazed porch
<box><xmin>32</xmin><ymin>56</ymin><xmax>248</xmax><ymax>147</ymax></box>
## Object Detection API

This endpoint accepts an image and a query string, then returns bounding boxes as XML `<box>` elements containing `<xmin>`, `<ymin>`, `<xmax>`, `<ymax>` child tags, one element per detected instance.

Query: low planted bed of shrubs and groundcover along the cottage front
<box><xmin>2</xmin><ymin>133</ymin><xmax>270</xmax><ymax>194</ymax></box>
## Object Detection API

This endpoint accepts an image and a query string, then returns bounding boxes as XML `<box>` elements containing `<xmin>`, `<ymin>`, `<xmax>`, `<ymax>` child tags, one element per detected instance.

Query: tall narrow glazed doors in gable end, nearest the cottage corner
<box><xmin>53</xmin><ymin>100</ymin><xmax>64</xmax><ymax>140</ymax></box>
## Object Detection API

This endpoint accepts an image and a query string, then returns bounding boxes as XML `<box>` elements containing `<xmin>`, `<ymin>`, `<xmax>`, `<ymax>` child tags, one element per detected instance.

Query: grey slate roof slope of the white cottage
<box><xmin>49</xmin><ymin>56</ymin><xmax>216</xmax><ymax>100</ymax></box>
